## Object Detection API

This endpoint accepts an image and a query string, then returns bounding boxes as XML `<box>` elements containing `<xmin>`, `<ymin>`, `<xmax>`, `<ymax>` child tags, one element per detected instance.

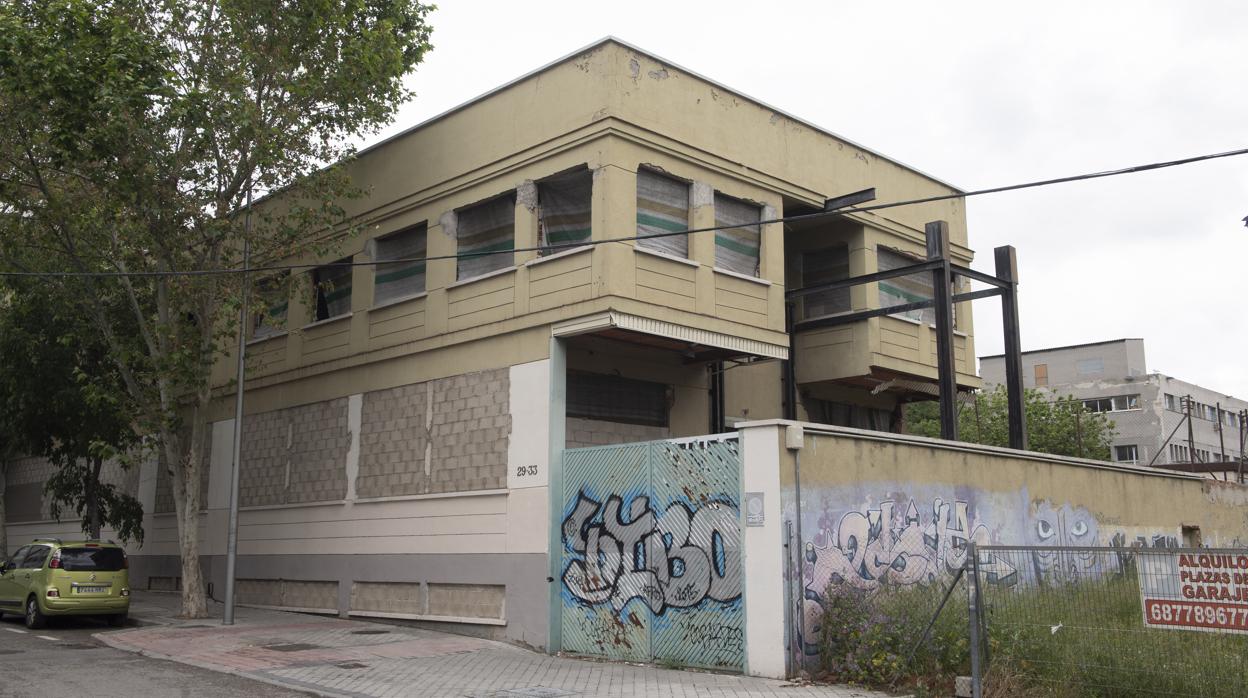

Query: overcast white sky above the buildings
<box><xmin>367</xmin><ymin>0</ymin><xmax>1248</xmax><ymax>398</ymax></box>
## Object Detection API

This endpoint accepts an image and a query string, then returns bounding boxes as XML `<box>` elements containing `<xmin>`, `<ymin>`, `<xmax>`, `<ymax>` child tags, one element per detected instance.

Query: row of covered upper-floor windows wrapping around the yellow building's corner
<box><xmin>253</xmin><ymin>167</ymin><xmax>763</xmax><ymax>338</ymax></box>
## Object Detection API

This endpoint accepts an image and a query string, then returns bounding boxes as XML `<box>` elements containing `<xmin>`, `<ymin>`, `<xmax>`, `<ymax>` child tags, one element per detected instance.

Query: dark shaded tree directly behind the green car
<box><xmin>0</xmin><ymin>282</ymin><xmax>144</xmax><ymax>543</ymax></box>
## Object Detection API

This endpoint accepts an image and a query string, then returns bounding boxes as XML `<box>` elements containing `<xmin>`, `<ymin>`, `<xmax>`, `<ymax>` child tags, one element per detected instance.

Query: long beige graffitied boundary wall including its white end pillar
<box><xmin>740</xmin><ymin>421</ymin><xmax>1248</xmax><ymax>677</ymax></box>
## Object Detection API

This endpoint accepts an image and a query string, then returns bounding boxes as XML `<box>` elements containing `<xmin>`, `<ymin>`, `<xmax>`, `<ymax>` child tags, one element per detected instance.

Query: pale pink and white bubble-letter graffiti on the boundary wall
<box><xmin>805</xmin><ymin>497</ymin><xmax>1005</xmax><ymax>594</ymax></box>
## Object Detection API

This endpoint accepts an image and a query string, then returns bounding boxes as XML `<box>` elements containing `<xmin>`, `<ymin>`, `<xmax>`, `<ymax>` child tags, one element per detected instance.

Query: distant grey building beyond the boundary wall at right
<box><xmin>980</xmin><ymin>338</ymin><xmax>1248</xmax><ymax>466</ymax></box>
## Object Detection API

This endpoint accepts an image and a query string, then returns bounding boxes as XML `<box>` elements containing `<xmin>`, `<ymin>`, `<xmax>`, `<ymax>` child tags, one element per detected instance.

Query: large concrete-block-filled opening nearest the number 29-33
<box><xmin>356</xmin><ymin>368</ymin><xmax>512</xmax><ymax>497</ymax></box>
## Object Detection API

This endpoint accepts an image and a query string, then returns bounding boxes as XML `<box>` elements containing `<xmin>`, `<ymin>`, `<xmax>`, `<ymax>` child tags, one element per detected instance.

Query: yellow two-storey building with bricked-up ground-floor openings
<box><xmin>9</xmin><ymin>39</ymin><xmax>980</xmax><ymax>647</ymax></box>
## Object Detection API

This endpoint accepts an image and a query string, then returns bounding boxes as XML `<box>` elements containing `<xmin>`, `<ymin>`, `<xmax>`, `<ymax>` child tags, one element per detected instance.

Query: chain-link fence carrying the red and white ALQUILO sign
<box><xmin>965</xmin><ymin>546</ymin><xmax>1248</xmax><ymax>698</ymax></box>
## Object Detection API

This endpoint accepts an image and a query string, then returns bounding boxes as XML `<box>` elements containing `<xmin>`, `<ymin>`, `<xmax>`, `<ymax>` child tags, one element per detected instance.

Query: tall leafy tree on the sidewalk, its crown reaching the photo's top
<box><xmin>0</xmin><ymin>0</ymin><xmax>431</xmax><ymax>617</ymax></box>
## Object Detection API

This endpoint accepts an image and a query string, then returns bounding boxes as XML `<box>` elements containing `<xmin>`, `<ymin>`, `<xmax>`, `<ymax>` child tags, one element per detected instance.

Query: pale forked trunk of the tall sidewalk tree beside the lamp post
<box><xmin>160</xmin><ymin>429</ymin><xmax>208</xmax><ymax>618</ymax></box>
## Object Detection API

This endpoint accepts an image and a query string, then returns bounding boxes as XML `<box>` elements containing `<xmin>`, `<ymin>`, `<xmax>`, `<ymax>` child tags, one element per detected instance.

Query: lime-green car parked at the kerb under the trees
<box><xmin>0</xmin><ymin>538</ymin><xmax>130</xmax><ymax>629</ymax></box>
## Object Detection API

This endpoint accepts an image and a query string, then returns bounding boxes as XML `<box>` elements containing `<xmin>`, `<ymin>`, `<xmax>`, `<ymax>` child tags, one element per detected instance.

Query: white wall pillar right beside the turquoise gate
<box><xmin>740</xmin><ymin>425</ymin><xmax>786</xmax><ymax>678</ymax></box>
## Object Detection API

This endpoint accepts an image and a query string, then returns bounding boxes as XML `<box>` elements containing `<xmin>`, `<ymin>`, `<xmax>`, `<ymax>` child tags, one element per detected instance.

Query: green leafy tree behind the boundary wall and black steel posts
<box><xmin>906</xmin><ymin>386</ymin><xmax>1113</xmax><ymax>461</ymax></box>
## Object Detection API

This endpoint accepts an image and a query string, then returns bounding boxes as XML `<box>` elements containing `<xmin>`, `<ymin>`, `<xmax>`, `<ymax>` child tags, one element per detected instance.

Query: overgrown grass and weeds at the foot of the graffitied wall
<box><xmin>816</xmin><ymin>573</ymin><xmax>1248</xmax><ymax>698</ymax></box>
